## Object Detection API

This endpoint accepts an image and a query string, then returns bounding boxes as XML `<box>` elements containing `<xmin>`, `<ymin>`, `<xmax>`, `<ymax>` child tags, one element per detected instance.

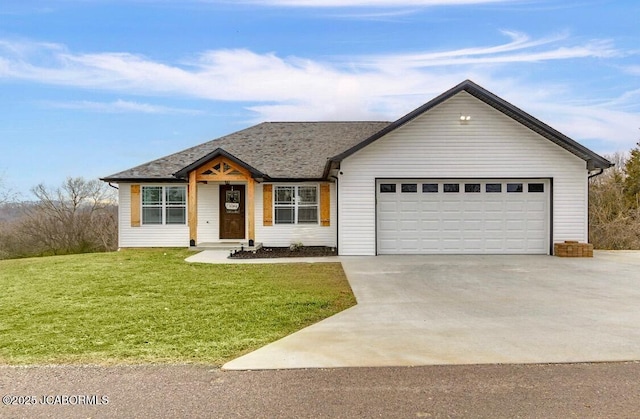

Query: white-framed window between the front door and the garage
<box><xmin>274</xmin><ymin>186</ymin><xmax>318</xmax><ymax>224</ymax></box>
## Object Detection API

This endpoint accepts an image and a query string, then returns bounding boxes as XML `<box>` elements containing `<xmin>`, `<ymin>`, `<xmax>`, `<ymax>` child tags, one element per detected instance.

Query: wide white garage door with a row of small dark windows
<box><xmin>376</xmin><ymin>179</ymin><xmax>551</xmax><ymax>254</ymax></box>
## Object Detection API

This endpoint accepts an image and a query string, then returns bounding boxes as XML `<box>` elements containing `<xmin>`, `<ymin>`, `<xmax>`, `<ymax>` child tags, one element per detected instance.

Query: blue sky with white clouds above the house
<box><xmin>0</xmin><ymin>0</ymin><xmax>640</xmax><ymax>199</ymax></box>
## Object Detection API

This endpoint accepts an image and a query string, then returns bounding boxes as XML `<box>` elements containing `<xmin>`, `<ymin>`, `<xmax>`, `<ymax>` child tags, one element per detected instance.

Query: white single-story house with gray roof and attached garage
<box><xmin>102</xmin><ymin>80</ymin><xmax>611</xmax><ymax>255</ymax></box>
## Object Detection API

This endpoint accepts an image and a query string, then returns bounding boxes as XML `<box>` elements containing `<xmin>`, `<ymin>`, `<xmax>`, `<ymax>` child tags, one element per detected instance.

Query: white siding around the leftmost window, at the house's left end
<box><xmin>118</xmin><ymin>183</ymin><xmax>189</xmax><ymax>247</ymax></box>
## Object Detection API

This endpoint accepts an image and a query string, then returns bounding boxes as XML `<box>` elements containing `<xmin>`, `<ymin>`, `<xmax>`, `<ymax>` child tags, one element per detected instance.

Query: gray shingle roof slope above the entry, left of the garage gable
<box><xmin>103</xmin><ymin>122</ymin><xmax>390</xmax><ymax>182</ymax></box>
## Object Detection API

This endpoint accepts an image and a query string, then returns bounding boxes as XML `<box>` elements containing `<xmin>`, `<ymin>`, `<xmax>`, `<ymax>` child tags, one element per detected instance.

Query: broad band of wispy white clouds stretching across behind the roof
<box><xmin>0</xmin><ymin>31</ymin><xmax>640</xmax><ymax>153</ymax></box>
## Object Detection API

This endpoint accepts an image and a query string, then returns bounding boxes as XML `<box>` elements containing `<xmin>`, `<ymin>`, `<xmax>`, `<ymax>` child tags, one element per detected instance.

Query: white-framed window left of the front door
<box><xmin>142</xmin><ymin>186</ymin><xmax>187</xmax><ymax>225</ymax></box>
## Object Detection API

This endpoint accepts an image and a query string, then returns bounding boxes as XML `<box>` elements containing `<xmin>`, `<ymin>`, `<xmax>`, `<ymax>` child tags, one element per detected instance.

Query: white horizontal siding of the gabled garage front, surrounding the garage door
<box><xmin>338</xmin><ymin>92</ymin><xmax>588</xmax><ymax>255</ymax></box>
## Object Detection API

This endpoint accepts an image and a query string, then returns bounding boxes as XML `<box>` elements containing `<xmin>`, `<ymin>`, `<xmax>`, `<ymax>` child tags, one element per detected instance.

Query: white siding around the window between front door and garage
<box><xmin>255</xmin><ymin>182</ymin><xmax>337</xmax><ymax>247</ymax></box>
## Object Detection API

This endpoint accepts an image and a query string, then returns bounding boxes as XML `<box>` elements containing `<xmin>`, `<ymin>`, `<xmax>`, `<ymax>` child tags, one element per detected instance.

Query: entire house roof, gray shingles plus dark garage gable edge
<box><xmin>103</xmin><ymin>80</ymin><xmax>611</xmax><ymax>182</ymax></box>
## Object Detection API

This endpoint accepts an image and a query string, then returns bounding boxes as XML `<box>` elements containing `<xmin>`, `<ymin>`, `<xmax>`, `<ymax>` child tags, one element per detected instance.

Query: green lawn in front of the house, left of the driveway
<box><xmin>0</xmin><ymin>249</ymin><xmax>355</xmax><ymax>365</ymax></box>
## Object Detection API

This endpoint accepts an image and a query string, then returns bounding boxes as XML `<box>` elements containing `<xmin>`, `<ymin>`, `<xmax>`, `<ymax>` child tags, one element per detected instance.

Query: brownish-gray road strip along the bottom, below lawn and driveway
<box><xmin>0</xmin><ymin>362</ymin><xmax>640</xmax><ymax>418</ymax></box>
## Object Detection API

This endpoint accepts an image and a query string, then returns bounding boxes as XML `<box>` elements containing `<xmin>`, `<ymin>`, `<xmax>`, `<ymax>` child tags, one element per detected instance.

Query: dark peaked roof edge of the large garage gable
<box><xmin>332</xmin><ymin>80</ymin><xmax>612</xmax><ymax>173</ymax></box>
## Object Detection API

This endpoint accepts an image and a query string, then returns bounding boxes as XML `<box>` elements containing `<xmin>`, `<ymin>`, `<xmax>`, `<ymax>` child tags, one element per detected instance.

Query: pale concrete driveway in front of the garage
<box><xmin>223</xmin><ymin>251</ymin><xmax>640</xmax><ymax>369</ymax></box>
